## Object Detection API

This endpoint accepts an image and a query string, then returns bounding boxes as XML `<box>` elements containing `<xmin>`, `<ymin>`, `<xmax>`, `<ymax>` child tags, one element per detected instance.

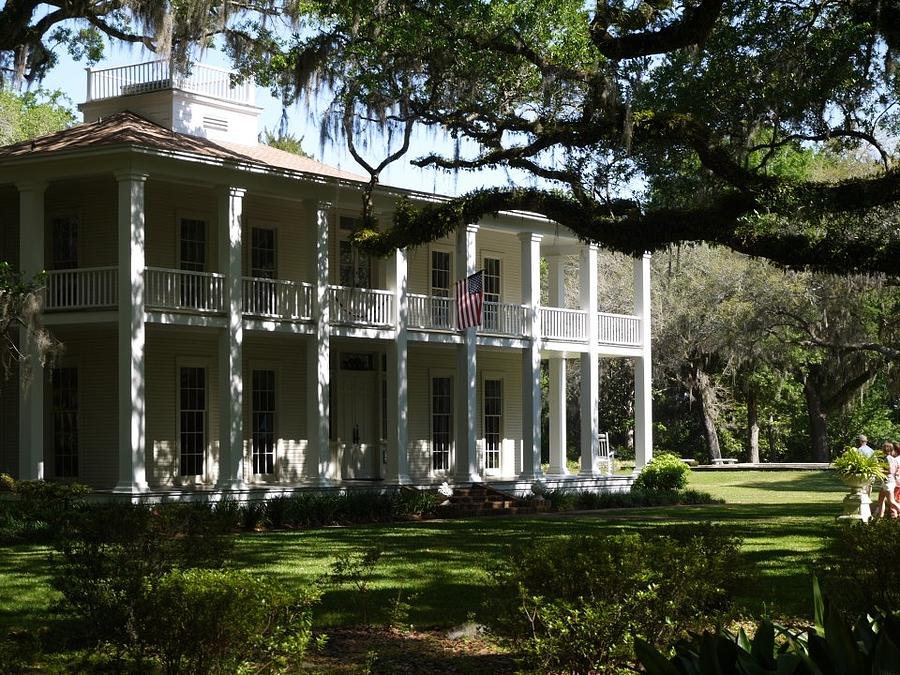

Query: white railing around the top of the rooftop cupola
<box><xmin>87</xmin><ymin>60</ymin><xmax>255</xmax><ymax>105</ymax></box>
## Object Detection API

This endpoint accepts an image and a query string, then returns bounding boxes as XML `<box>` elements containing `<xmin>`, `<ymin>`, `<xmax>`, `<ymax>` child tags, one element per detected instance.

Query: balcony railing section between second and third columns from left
<box><xmin>144</xmin><ymin>267</ymin><xmax>225</xmax><ymax>314</ymax></box>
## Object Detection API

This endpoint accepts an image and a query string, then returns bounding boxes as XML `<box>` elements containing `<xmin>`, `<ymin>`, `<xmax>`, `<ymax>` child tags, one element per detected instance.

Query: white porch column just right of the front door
<box><xmin>388</xmin><ymin>249</ymin><xmax>411</xmax><ymax>485</ymax></box>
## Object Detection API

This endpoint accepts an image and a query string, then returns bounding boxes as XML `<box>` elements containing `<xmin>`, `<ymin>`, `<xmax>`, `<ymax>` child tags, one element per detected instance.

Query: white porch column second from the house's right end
<box><xmin>579</xmin><ymin>245</ymin><xmax>600</xmax><ymax>476</ymax></box>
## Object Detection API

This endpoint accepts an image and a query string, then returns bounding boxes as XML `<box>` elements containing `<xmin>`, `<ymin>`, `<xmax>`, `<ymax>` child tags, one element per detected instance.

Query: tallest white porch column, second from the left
<box><xmin>115</xmin><ymin>171</ymin><xmax>147</xmax><ymax>493</ymax></box>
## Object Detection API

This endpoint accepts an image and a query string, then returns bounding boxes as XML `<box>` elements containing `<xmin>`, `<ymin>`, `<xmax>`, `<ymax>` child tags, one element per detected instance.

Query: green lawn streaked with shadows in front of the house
<box><xmin>0</xmin><ymin>471</ymin><xmax>843</xmax><ymax>630</ymax></box>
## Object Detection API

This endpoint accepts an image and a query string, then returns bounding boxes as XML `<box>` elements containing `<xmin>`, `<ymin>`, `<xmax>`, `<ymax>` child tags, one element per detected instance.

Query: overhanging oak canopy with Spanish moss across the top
<box><xmin>0</xmin><ymin>0</ymin><xmax>900</xmax><ymax>274</ymax></box>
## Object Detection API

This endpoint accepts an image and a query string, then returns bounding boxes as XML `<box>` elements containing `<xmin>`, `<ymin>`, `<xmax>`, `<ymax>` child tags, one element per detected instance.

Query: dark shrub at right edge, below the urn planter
<box><xmin>815</xmin><ymin>518</ymin><xmax>900</xmax><ymax>617</ymax></box>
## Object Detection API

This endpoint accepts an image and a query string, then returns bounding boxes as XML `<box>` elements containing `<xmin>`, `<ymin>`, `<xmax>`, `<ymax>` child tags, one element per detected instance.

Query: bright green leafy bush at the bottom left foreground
<box><xmin>134</xmin><ymin>569</ymin><xmax>319</xmax><ymax>675</ymax></box>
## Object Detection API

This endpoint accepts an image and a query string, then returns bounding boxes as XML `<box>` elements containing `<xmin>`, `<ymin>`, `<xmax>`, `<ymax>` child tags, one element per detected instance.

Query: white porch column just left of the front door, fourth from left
<box><xmin>306</xmin><ymin>202</ymin><xmax>337</xmax><ymax>485</ymax></box>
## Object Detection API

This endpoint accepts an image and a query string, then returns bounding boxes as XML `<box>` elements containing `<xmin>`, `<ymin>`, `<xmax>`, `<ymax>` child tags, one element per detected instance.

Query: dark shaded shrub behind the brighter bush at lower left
<box><xmin>52</xmin><ymin>503</ymin><xmax>233</xmax><ymax>644</ymax></box>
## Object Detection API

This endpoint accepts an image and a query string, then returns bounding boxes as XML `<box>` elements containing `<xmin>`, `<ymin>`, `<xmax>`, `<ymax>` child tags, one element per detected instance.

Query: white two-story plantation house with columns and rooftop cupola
<box><xmin>0</xmin><ymin>62</ymin><xmax>651</xmax><ymax>496</ymax></box>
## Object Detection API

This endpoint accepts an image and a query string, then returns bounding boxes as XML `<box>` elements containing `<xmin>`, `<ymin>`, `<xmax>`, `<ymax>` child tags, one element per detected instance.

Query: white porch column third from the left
<box><xmin>217</xmin><ymin>187</ymin><xmax>246</xmax><ymax>490</ymax></box>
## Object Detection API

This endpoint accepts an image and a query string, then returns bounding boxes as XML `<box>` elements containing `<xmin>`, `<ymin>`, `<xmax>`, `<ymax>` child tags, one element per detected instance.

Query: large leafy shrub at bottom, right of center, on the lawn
<box><xmin>492</xmin><ymin>525</ymin><xmax>745</xmax><ymax>673</ymax></box>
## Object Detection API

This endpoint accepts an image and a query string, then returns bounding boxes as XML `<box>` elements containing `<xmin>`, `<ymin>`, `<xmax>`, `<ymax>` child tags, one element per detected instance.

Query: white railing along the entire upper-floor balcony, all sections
<box><xmin>45</xmin><ymin>267</ymin><xmax>641</xmax><ymax>347</ymax></box>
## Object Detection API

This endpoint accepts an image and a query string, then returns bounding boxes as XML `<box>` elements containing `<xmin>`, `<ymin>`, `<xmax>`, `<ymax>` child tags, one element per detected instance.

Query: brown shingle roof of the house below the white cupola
<box><xmin>0</xmin><ymin>111</ymin><xmax>365</xmax><ymax>181</ymax></box>
